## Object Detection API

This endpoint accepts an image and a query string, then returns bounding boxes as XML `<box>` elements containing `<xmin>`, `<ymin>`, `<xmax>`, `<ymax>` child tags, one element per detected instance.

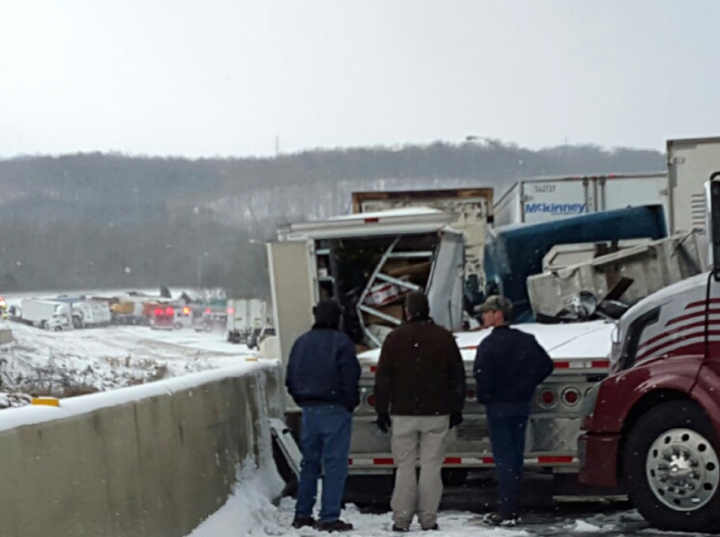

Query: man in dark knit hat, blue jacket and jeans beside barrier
<box><xmin>285</xmin><ymin>300</ymin><xmax>360</xmax><ymax>531</ymax></box>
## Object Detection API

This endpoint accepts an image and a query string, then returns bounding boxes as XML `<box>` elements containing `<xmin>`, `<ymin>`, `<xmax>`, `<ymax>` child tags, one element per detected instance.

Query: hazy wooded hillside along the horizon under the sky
<box><xmin>0</xmin><ymin>141</ymin><xmax>665</xmax><ymax>296</ymax></box>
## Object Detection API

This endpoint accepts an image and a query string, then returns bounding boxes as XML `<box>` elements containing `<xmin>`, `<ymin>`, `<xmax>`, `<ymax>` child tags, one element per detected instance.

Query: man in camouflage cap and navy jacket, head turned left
<box><xmin>473</xmin><ymin>295</ymin><xmax>553</xmax><ymax>526</ymax></box>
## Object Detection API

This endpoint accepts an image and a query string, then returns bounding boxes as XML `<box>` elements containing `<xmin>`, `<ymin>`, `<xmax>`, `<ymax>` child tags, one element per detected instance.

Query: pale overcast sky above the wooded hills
<box><xmin>0</xmin><ymin>0</ymin><xmax>720</xmax><ymax>158</ymax></box>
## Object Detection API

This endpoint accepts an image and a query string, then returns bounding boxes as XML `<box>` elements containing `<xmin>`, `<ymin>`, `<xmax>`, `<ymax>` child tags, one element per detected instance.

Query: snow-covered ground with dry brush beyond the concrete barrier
<box><xmin>0</xmin><ymin>288</ymin><xmax>256</xmax><ymax>408</ymax></box>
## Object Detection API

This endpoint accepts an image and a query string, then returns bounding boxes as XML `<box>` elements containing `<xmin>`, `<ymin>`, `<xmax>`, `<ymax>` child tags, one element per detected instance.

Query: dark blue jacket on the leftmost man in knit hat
<box><xmin>285</xmin><ymin>325</ymin><xmax>361</xmax><ymax>411</ymax></box>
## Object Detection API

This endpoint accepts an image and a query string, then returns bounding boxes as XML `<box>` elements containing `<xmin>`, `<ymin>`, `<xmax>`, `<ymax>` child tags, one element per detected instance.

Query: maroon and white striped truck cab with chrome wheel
<box><xmin>578</xmin><ymin>173</ymin><xmax>720</xmax><ymax>532</ymax></box>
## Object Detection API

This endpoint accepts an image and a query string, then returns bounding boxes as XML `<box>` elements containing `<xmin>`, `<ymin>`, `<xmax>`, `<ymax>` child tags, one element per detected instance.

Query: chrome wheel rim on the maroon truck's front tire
<box><xmin>645</xmin><ymin>429</ymin><xmax>720</xmax><ymax>511</ymax></box>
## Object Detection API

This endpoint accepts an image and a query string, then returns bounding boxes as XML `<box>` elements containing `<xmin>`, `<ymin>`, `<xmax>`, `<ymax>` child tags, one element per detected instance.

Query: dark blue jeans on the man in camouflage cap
<box><xmin>486</xmin><ymin>403</ymin><xmax>530</xmax><ymax>517</ymax></box>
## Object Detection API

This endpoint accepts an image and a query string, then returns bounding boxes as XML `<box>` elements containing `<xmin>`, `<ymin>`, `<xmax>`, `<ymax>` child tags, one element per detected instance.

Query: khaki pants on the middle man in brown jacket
<box><xmin>390</xmin><ymin>416</ymin><xmax>449</xmax><ymax>528</ymax></box>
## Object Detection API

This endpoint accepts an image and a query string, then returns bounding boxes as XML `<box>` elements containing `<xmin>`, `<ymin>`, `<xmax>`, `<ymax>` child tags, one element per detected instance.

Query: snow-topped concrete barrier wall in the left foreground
<box><xmin>0</xmin><ymin>362</ymin><xmax>281</xmax><ymax>537</ymax></box>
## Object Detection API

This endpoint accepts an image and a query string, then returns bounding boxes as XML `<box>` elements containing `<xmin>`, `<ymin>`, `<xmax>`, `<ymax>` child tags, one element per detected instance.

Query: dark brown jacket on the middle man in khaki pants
<box><xmin>375</xmin><ymin>318</ymin><xmax>467</xmax><ymax>416</ymax></box>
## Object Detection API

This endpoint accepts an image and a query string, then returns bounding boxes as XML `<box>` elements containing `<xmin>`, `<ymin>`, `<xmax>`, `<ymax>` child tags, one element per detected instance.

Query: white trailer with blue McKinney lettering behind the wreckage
<box><xmin>493</xmin><ymin>173</ymin><xmax>672</xmax><ymax>230</ymax></box>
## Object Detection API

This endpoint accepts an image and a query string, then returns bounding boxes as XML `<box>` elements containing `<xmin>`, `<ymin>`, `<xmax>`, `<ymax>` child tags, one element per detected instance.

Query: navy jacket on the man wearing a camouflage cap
<box><xmin>473</xmin><ymin>326</ymin><xmax>554</xmax><ymax>404</ymax></box>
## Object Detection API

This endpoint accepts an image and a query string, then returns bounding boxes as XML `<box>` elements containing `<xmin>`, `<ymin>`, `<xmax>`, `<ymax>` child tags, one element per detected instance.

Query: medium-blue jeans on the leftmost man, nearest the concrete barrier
<box><xmin>295</xmin><ymin>406</ymin><xmax>352</xmax><ymax>522</ymax></box>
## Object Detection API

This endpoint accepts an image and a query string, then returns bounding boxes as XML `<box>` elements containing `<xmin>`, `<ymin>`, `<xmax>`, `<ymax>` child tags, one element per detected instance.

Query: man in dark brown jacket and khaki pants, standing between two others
<box><xmin>375</xmin><ymin>292</ymin><xmax>466</xmax><ymax>532</ymax></box>
